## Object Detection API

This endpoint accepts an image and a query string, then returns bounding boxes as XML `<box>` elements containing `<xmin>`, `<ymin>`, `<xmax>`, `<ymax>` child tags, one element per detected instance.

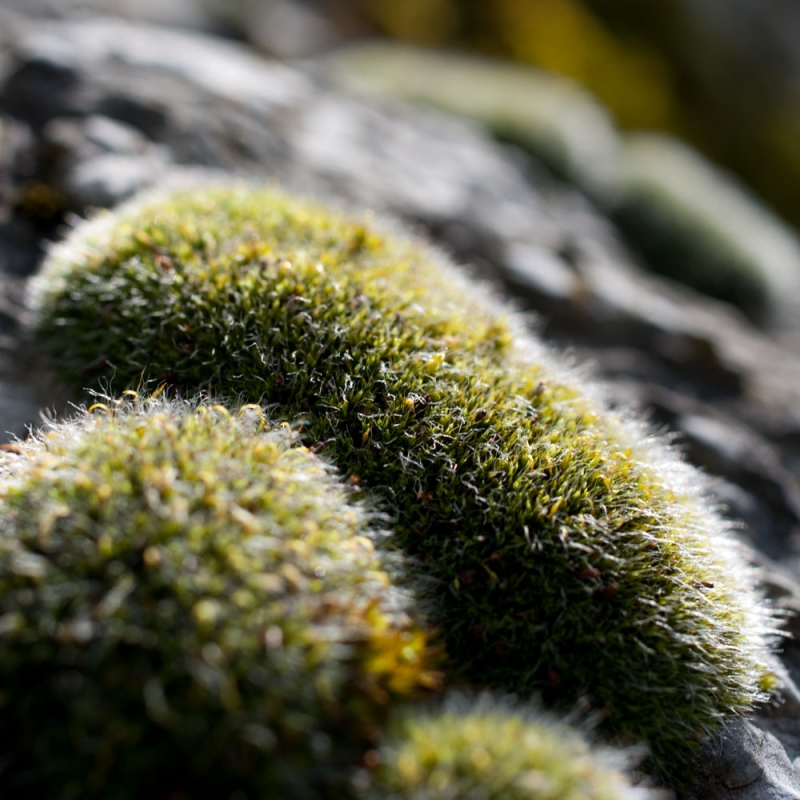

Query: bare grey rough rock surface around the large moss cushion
<box><xmin>0</xmin><ymin>3</ymin><xmax>800</xmax><ymax>800</ymax></box>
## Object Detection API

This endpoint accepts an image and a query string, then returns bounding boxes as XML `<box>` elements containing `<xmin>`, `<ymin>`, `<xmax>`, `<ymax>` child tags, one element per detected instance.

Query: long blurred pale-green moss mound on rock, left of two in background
<box><xmin>326</xmin><ymin>42</ymin><xmax>619</xmax><ymax>194</ymax></box>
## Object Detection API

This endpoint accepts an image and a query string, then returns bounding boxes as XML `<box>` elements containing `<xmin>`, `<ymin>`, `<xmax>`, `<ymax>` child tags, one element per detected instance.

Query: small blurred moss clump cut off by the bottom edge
<box><xmin>368</xmin><ymin>696</ymin><xmax>653</xmax><ymax>800</ymax></box>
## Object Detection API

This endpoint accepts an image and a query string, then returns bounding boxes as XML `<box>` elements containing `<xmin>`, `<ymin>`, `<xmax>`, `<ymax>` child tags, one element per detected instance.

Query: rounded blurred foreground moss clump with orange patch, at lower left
<box><xmin>0</xmin><ymin>404</ymin><xmax>434</xmax><ymax>800</ymax></box>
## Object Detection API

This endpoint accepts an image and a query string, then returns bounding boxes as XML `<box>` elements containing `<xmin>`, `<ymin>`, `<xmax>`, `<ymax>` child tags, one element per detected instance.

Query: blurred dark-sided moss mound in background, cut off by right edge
<box><xmin>612</xmin><ymin>134</ymin><xmax>800</xmax><ymax>320</ymax></box>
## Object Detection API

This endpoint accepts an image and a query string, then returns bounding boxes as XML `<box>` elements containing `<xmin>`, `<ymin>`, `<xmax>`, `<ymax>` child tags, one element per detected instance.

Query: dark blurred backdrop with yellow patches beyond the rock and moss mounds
<box><xmin>6</xmin><ymin>0</ymin><xmax>800</xmax><ymax>225</ymax></box>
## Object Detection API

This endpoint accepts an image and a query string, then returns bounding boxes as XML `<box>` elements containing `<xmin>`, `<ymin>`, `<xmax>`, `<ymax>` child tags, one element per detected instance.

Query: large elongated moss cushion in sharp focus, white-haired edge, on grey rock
<box><xmin>32</xmin><ymin>188</ymin><xmax>766</xmax><ymax>776</ymax></box>
